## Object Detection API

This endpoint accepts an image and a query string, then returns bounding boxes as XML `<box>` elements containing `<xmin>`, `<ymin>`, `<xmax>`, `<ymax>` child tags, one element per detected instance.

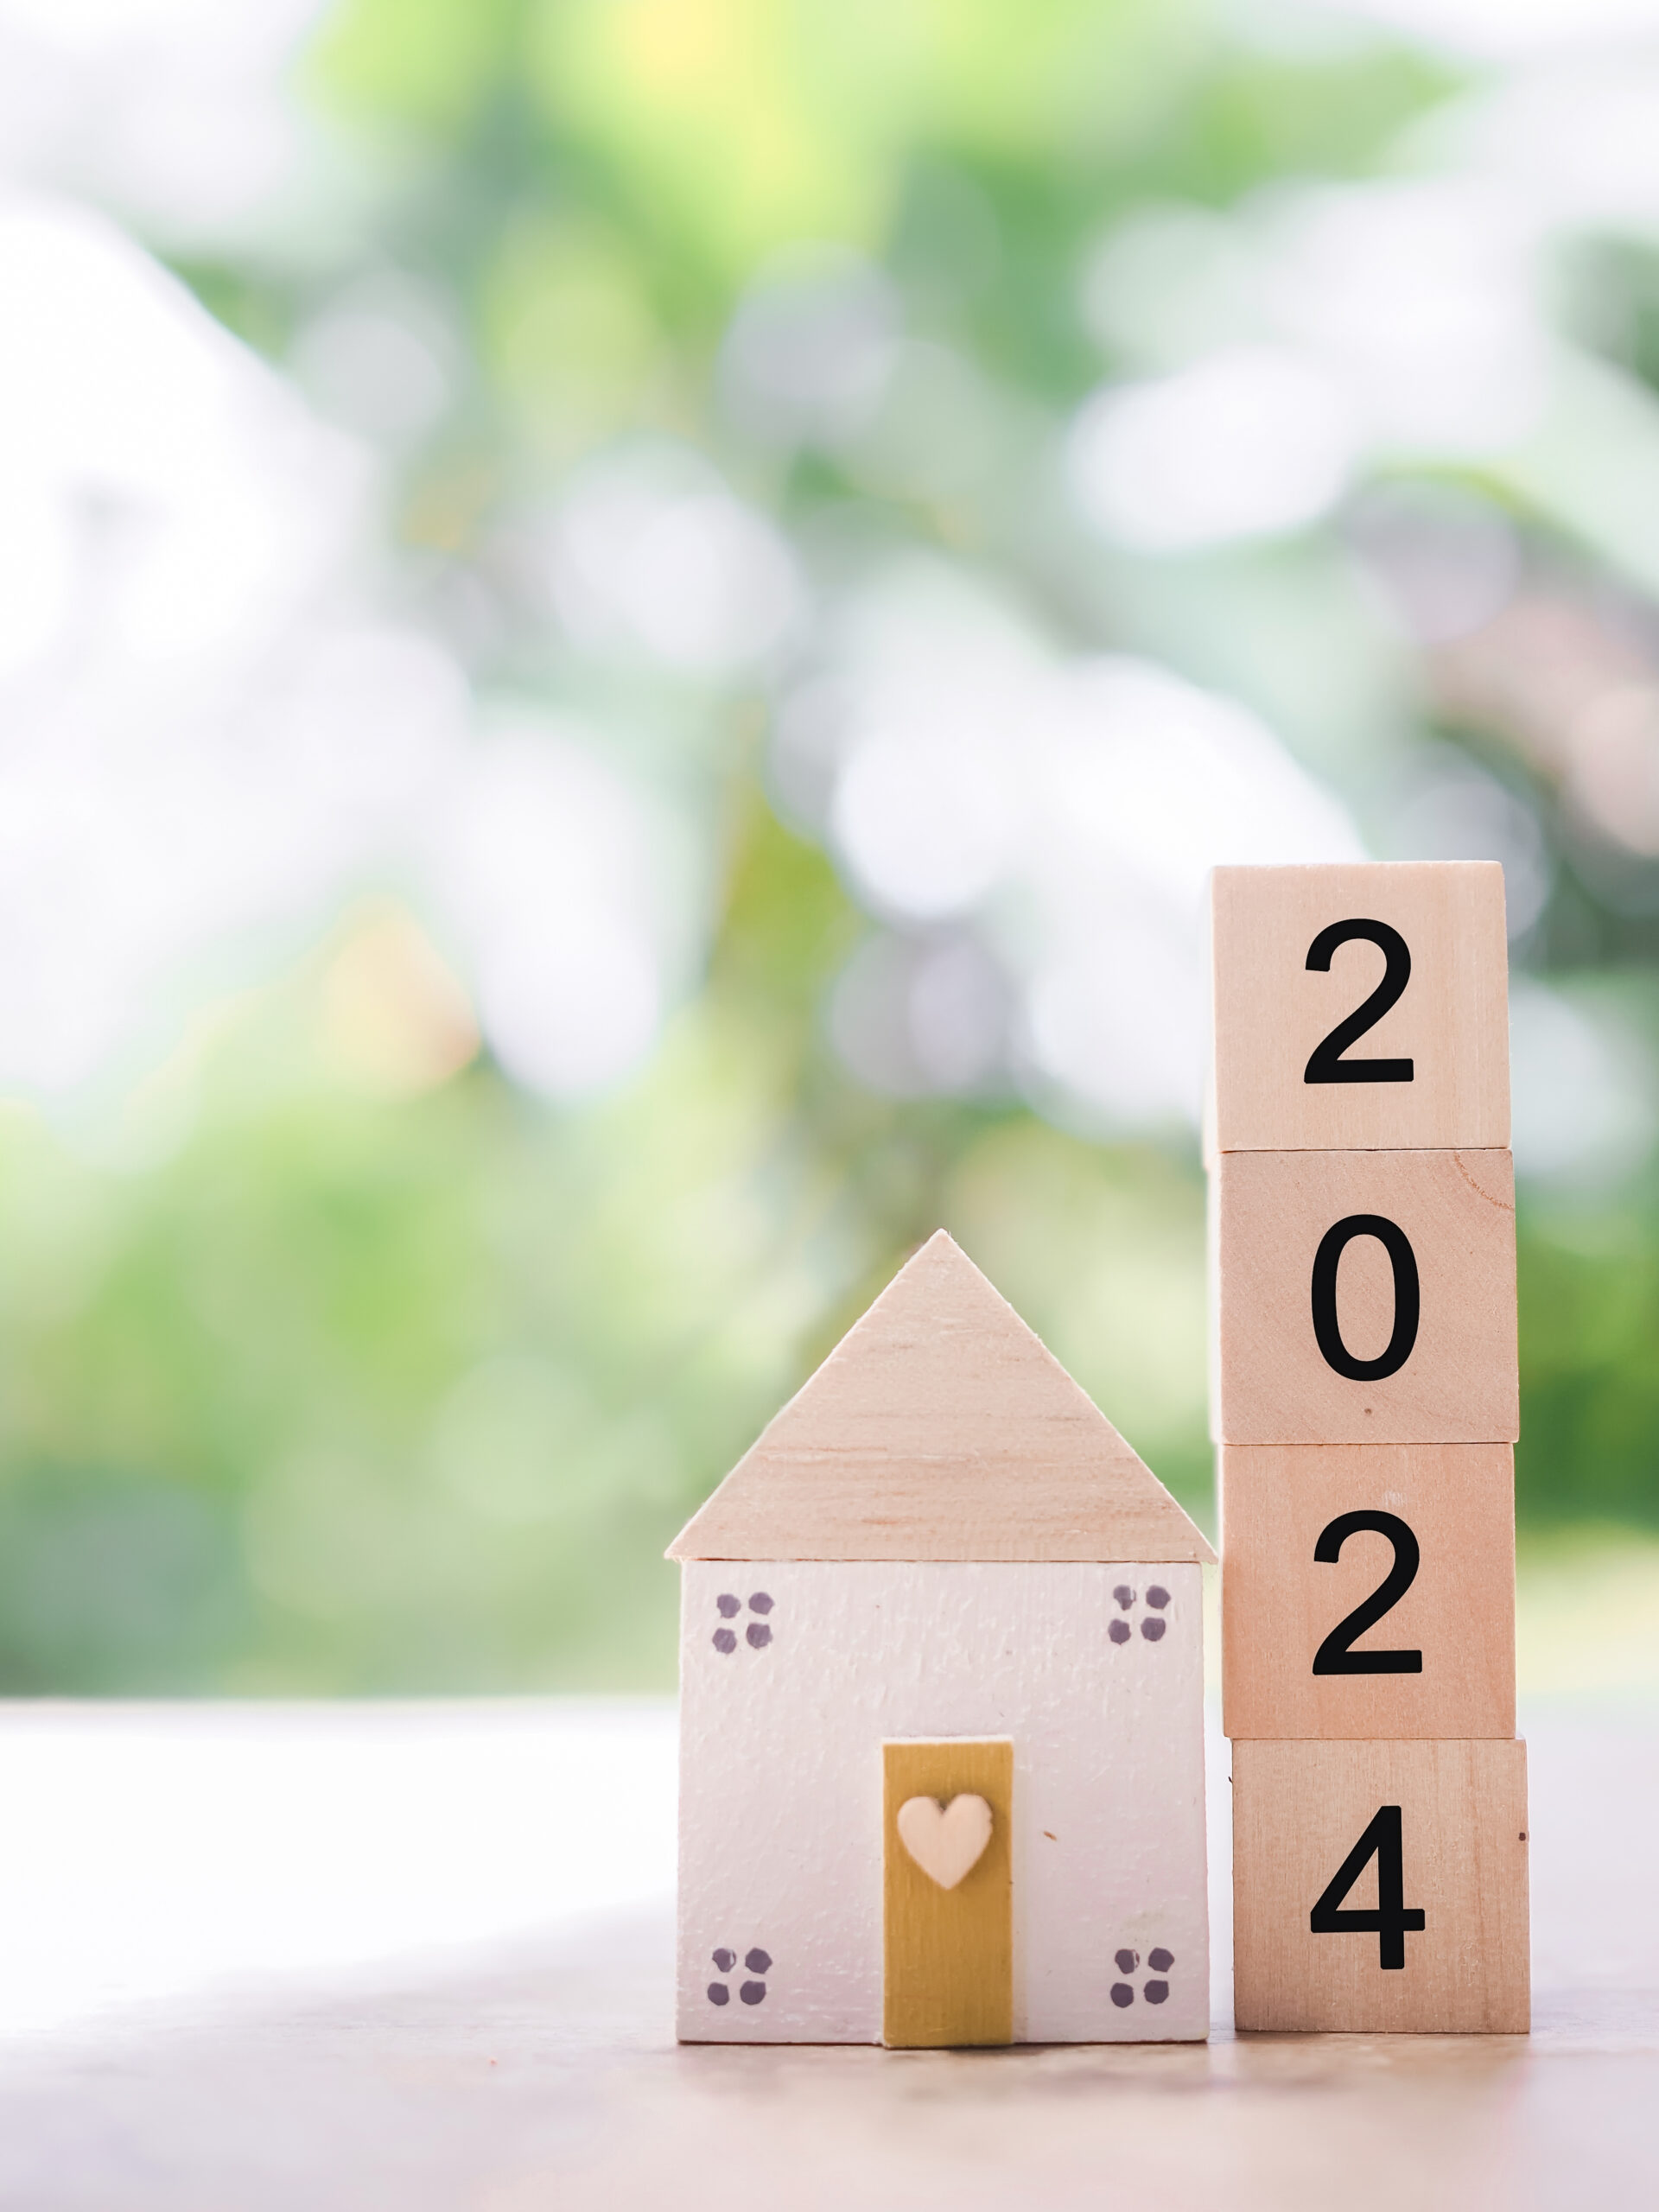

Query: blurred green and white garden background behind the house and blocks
<box><xmin>0</xmin><ymin>0</ymin><xmax>1659</xmax><ymax>1690</ymax></box>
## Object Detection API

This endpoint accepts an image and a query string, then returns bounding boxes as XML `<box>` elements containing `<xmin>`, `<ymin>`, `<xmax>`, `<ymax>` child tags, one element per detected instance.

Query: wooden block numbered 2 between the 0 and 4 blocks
<box><xmin>1221</xmin><ymin>1445</ymin><xmax>1516</xmax><ymax>1738</ymax></box>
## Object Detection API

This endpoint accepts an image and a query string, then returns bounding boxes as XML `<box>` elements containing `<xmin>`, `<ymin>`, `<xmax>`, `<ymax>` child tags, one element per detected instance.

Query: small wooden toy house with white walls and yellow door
<box><xmin>668</xmin><ymin>1232</ymin><xmax>1212</xmax><ymax>2044</ymax></box>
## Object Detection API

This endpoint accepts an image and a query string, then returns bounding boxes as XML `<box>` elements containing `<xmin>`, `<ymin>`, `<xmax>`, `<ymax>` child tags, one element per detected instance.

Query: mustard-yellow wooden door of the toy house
<box><xmin>880</xmin><ymin>1737</ymin><xmax>1013</xmax><ymax>2049</ymax></box>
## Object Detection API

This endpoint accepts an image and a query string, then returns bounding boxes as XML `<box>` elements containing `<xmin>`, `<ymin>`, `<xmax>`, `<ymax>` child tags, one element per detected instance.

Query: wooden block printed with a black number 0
<box><xmin>1214</xmin><ymin>1153</ymin><xmax>1520</xmax><ymax>1445</ymax></box>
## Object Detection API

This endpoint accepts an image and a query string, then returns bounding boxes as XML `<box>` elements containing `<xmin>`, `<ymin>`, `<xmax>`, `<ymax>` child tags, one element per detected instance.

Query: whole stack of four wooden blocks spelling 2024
<box><xmin>1208</xmin><ymin>862</ymin><xmax>1529</xmax><ymax>2033</ymax></box>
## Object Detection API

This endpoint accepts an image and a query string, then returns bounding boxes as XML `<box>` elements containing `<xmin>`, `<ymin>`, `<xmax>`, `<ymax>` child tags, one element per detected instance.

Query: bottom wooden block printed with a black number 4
<box><xmin>1232</xmin><ymin>1741</ymin><xmax>1531</xmax><ymax>2035</ymax></box>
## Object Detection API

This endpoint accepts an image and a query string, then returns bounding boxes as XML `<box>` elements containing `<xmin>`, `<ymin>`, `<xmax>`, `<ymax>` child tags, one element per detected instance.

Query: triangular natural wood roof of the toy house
<box><xmin>668</xmin><ymin>1230</ymin><xmax>1214</xmax><ymax>1561</ymax></box>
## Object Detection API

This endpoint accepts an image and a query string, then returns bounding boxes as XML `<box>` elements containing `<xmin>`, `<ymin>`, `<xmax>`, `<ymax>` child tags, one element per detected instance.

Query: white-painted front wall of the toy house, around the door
<box><xmin>677</xmin><ymin>1560</ymin><xmax>1210</xmax><ymax>2044</ymax></box>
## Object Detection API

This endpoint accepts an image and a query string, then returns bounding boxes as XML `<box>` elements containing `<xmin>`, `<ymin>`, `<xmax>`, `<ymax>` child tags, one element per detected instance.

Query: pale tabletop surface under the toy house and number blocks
<box><xmin>0</xmin><ymin>1699</ymin><xmax>1659</xmax><ymax>2212</ymax></box>
